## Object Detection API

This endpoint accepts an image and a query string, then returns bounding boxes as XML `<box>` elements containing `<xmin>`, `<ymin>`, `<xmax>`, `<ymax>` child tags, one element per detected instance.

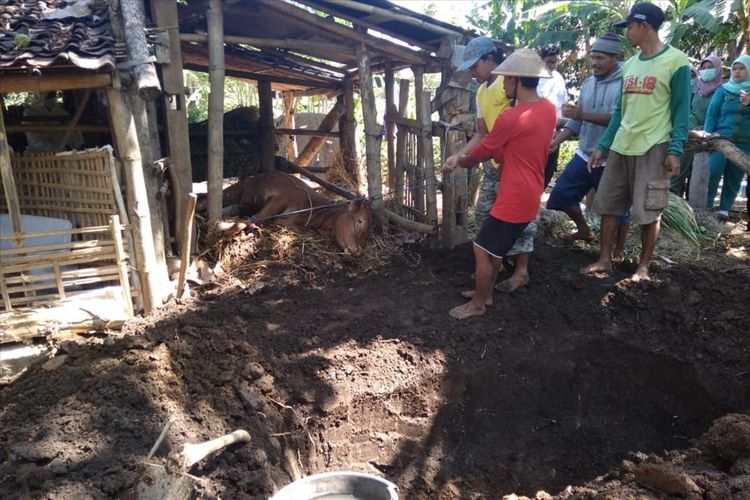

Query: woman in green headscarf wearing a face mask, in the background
<box><xmin>669</xmin><ymin>56</ymin><xmax>722</xmax><ymax>196</ymax></box>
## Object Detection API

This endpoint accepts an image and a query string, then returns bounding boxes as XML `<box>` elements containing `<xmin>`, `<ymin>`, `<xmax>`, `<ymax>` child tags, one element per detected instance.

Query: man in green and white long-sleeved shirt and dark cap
<box><xmin>581</xmin><ymin>2</ymin><xmax>690</xmax><ymax>281</ymax></box>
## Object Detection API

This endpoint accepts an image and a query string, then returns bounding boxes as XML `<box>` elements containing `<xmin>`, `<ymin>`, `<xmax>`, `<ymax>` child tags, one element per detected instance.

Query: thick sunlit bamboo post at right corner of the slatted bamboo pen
<box><xmin>107</xmin><ymin>88</ymin><xmax>161</xmax><ymax>314</ymax></box>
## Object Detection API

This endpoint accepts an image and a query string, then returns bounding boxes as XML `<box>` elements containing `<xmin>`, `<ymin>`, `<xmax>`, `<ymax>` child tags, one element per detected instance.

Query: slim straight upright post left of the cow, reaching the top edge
<box><xmin>207</xmin><ymin>0</ymin><xmax>224</xmax><ymax>221</ymax></box>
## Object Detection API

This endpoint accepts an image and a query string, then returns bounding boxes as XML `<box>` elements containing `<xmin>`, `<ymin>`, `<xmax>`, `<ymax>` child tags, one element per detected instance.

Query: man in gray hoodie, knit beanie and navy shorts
<box><xmin>547</xmin><ymin>33</ymin><xmax>627</xmax><ymax>250</ymax></box>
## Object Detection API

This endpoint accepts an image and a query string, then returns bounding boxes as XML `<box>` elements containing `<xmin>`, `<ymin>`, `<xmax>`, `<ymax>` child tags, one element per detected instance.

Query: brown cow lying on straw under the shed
<box><xmin>223</xmin><ymin>171</ymin><xmax>371</xmax><ymax>256</ymax></box>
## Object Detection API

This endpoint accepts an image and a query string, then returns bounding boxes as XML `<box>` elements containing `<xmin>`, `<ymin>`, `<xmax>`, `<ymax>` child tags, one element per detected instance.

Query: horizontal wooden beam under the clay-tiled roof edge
<box><xmin>0</xmin><ymin>71</ymin><xmax>112</xmax><ymax>94</ymax></box>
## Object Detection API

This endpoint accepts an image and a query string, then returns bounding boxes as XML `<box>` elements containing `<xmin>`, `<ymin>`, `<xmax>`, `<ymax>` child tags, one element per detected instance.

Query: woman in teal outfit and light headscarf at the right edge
<box><xmin>704</xmin><ymin>55</ymin><xmax>750</xmax><ymax>221</ymax></box>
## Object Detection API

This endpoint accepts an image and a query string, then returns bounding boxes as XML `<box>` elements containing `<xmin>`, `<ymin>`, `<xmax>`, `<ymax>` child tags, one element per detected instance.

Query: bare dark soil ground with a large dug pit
<box><xmin>0</xmin><ymin>228</ymin><xmax>750</xmax><ymax>500</ymax></box>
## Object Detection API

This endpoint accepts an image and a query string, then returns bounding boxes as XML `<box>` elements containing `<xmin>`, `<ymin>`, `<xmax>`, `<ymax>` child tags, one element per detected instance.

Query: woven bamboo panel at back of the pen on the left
<box><xmin>0</xmin><ymin>148</ymin><xmax>118</xmax><ymax>234</ymax></box>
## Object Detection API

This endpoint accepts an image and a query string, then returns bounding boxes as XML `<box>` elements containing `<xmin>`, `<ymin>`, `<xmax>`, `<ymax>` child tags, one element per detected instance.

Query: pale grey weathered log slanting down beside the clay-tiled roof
<box><xmin>120</xmin><ymin>0</ymin><xmax>161</xmax><ymax>101</ymax></box>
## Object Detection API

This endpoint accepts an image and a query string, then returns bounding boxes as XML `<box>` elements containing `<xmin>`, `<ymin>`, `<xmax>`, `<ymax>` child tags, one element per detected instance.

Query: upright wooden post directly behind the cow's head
<box><xmin>357</xmin><ymin>43</ymin><xmax>383</xmax><ymax>208</ymax></box>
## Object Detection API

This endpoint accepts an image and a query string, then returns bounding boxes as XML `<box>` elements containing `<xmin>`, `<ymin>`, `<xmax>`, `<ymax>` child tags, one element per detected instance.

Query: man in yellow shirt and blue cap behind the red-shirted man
<box><xmin>443</xmin><ymin>36</ymin><xmax>537</xmax><ymax>292</ymax></box>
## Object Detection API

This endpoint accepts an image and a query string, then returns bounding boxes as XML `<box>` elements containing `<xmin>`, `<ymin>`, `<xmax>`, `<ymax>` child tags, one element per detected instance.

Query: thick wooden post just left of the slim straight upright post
<box><xmin>150</xmin><ymin>1</ymin><xmax>193</xmax><ymax>250</ymax></box>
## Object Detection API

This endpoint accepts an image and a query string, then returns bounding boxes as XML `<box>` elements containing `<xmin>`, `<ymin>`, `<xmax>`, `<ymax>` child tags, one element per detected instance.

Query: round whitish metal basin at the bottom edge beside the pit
<box><xmin>271</xmin><ymin>472</ymin><xmax>398</xmax><ymax>500</ymax></box>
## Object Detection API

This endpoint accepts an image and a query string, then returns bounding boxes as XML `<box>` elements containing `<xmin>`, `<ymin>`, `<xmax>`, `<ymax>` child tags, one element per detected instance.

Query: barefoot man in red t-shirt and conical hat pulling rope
<box><xmin>443</xmin><ymin>49</ymin><xmax>557</xmax><ymax>319</ymax></box>
